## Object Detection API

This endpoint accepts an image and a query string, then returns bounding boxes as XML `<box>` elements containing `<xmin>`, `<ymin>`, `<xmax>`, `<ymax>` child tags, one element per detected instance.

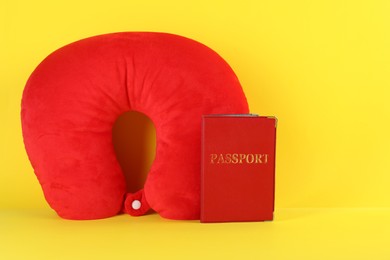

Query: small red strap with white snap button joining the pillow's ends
<box><xmin>123</xmin><ymin>189</ymin><xmax>150</xmax><ymax>217</ymax></box>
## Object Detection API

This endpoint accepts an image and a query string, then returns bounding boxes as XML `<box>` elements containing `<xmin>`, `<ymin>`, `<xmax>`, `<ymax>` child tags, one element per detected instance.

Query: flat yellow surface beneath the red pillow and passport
<box><xmin>0</xmin><ymin>209</ymin><xmax>390</xmax><ymax>260</ymax></box>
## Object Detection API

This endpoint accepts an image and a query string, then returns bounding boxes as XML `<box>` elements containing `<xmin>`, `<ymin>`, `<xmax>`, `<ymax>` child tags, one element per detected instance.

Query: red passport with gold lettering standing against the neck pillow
<box><xmin>200</xmin><ymin>114</ymin><xmax>277</xmax><ymax>222</ymax></box>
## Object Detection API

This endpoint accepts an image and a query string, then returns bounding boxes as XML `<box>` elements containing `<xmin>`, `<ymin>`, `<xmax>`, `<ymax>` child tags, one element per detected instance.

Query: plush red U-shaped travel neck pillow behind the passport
<box><xmin>21</xmin><ymin>32</ymin><xmax>248</xmax><ymax>219</ymax></box>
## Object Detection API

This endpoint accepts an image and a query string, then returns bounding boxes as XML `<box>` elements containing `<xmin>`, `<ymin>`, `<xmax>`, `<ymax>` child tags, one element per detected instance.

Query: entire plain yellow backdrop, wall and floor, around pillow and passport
<box><xmin>0</xmin><ymin>0</ymin><xmax>390</xmax><ymax>259</ymax></box>
